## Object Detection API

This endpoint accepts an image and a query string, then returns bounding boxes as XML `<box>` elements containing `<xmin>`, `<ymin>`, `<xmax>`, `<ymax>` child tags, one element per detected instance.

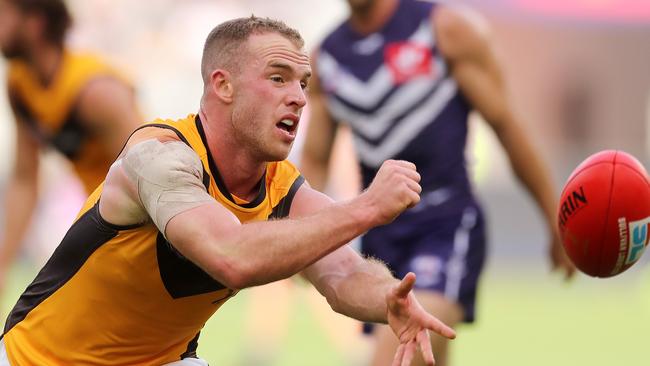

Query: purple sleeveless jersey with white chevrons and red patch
<box><xmin>316</xmin><ymin>0</ymin><xmax>470</xmax><ymax>197</ymax></box>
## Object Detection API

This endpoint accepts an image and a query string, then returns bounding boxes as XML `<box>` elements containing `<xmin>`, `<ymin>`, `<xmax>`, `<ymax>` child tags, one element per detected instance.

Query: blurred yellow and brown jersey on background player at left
<box><xmin>7</xmin><ymin>51</ymin><xmax>132</xmax><ymax>193</ymax></box>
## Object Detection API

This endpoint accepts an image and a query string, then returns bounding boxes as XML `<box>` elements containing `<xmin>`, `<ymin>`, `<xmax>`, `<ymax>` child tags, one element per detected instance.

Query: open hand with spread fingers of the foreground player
<box><xmin>386</xmin><ymin>272</ymin><xmax>456</xmax><ymax>366</ymax></box>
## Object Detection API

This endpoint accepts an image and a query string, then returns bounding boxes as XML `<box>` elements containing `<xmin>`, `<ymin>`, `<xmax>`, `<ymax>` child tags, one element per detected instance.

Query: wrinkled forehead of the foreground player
<box><xmin>248</xmin><ymin>33</ymin><xmax>311</xmax><ymax>73</ymax></box>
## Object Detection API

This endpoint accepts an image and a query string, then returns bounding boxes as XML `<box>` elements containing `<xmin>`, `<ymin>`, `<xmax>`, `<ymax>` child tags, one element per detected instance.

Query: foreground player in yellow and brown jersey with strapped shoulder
<box><xmin>0</xmin><ymin>17</ymin><xmax>455</xmax><ymax>366</ymax></box>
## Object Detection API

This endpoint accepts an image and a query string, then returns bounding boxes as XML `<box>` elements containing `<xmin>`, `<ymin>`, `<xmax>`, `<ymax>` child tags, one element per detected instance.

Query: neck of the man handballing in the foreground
<box><xmin>199</xmin><ymin>110</ymin><xmax>266</xmax><ymax>201</ymax></box>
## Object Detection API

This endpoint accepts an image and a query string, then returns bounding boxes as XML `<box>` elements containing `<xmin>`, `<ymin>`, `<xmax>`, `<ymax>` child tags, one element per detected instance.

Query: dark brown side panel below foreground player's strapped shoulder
<box><xmin>3</xmin><ymin>203</ymin><xmax>140</xmax><ymax>336</ymax></box>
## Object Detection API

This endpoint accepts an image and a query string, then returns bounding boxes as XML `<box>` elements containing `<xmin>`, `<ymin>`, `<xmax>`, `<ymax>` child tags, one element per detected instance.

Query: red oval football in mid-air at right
<box><xmin>558</xmin><ymin>150</ymin><xmax>650</xmax><ymax>277</ymax></box>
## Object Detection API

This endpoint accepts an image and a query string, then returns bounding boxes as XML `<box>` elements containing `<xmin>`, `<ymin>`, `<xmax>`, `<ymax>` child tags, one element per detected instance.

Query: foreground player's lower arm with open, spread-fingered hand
<box><xmin>298</xmin><ymin>188</ymin><xmax>455</xmax><ymax>365</ymax></box>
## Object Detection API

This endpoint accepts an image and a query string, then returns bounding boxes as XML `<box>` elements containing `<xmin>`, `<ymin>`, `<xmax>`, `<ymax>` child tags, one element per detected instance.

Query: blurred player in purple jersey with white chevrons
<box><xmin>301</xmin><ymin>0</ymin><xmax>575</xmax><ymax>366</ymax></box>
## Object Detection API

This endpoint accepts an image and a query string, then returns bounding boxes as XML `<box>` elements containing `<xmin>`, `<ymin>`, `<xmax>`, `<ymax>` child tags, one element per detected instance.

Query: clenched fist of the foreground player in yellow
<box><xmin>360</xmin><ymin>160</ymin><xmax>422</xmax><ymax>226</ymax></box>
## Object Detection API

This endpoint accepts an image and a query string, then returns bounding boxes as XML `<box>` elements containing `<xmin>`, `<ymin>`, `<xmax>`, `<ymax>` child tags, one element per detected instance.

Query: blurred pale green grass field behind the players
<box><xmin>2</xmin><ymin>262</ymin><xmax>650</xmax><ymax>366</ymax></box>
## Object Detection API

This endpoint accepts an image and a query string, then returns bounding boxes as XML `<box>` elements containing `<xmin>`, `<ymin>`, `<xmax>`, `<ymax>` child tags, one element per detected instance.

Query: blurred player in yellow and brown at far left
<box><xmin>0</xmin><ymin>0</ymin><xmax>140</xmax><ymax>294</ymax></box>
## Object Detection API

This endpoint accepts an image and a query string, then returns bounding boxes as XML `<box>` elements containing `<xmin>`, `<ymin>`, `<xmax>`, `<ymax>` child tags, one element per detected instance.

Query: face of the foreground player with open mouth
<box><xmin>232</xmin><ymin>33</ymin><xmax>311</xmax><ymax>161</ymax></box>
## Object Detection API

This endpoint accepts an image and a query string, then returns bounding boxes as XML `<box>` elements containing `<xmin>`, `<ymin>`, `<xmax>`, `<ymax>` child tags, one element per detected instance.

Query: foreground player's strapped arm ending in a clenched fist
<box><xmin>99</xmin><ymin>132</ymin><xmax>420</xmax><ymax>289</ymax></box>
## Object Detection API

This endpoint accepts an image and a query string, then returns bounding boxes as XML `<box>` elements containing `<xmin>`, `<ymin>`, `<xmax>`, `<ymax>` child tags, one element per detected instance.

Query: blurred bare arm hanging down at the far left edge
<box><xmin>0</xmin><ymin>113</ymin><xmax>39</xmax><ymax>292</ymax></box>
